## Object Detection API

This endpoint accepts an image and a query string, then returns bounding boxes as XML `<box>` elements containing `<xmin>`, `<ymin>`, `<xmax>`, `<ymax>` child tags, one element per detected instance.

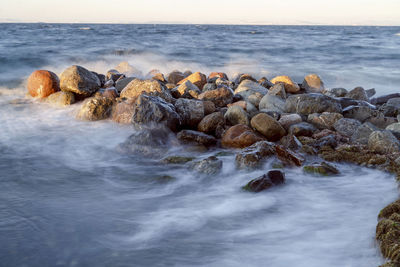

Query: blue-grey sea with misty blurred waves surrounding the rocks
<box><xmin>0</xmin><ymin>23</ymin><xmax>400</xmax><ymax>267</ymax></box>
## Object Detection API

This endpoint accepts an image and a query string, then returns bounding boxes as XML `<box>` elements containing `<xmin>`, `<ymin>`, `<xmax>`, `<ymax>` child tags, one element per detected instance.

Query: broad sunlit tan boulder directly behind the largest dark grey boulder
<box><xmin>121</xmin><ymin>79</ymin><xmax>172</xmax><ymax>102</ymax></box>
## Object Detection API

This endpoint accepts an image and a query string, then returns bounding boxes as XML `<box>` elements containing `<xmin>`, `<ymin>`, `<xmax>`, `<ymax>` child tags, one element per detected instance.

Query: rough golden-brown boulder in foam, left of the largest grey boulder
<box><xmin>76</xmin><ymin>97</ymin><xmax>113</xmax><ymax>121</ymax></box>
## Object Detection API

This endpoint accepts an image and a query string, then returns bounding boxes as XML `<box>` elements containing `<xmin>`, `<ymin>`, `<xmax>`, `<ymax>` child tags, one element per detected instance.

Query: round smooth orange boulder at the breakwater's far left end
<box><xmin>28</xmin><ymin>70</ymin><xmax>60</xmax><ymax>98</ymax></box>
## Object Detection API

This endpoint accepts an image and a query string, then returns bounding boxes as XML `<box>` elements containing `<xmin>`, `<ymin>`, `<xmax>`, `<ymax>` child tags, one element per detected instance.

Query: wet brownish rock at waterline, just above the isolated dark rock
<box><xmin>235</xmin><ymin>141</ymin><xmax>275</xmax><ymax>169</ymax></box>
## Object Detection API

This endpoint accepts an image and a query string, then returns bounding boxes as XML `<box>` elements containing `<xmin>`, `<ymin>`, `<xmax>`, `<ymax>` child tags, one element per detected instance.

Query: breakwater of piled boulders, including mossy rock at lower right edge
<box><xmin>27</xmin><ymin>62</ymin><xmax>400</xmax><ymax>266</ymax></box>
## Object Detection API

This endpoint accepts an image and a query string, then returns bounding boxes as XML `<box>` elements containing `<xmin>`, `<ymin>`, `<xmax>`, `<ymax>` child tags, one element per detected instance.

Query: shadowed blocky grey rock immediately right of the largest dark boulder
<box><xmin>175</xmin><ymin>98</ymin><xmax>204</xmax><ymax>128</ymax></box>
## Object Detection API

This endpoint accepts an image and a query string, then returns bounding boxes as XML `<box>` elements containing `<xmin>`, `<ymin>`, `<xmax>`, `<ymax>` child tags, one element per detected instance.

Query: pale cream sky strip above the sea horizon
<box><xmin>0</xmin><ymin>0</ymin><xmax>400</xmax><ymax>26</ymax></box>
